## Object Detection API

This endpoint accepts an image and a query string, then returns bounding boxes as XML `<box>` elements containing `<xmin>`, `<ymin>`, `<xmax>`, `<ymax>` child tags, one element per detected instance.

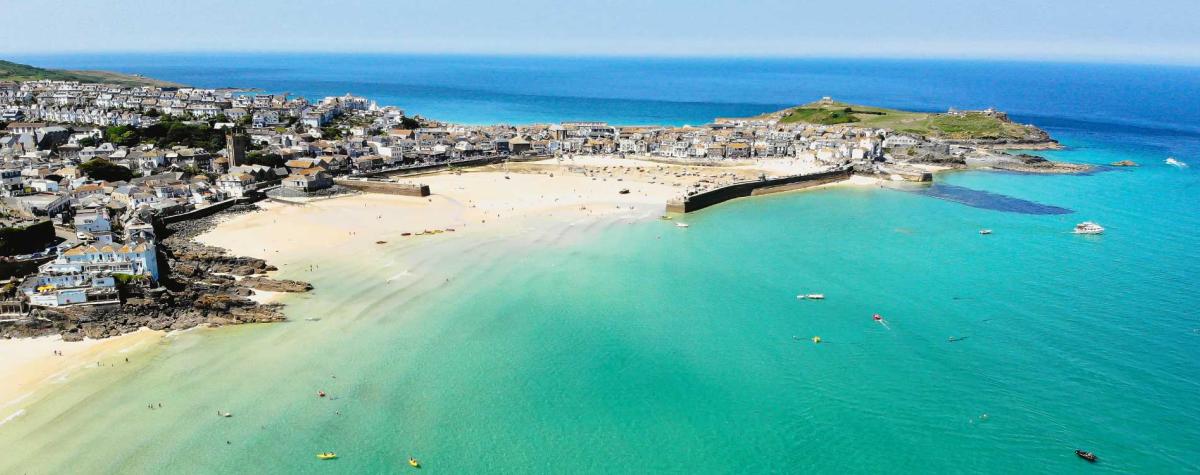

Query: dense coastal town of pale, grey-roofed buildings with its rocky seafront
<box><xmin>0</xmin><ymin>76</ymin><xmax>1070</xmax><ymax>338</ymax></box>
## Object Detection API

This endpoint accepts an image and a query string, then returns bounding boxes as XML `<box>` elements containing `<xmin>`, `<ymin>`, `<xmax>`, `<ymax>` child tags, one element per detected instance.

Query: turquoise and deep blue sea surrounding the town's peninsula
<box><xmin>0</xmin><ymin>54</ymin><xmax>1200</xmax><ymax>474</ymax></box>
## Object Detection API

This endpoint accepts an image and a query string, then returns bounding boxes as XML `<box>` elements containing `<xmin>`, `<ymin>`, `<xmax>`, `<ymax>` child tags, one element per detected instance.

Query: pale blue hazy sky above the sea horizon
<box><xmin>0</xmin><ymin>0</ymin><xmax>1200</xmax><ymax>65</ymax></box>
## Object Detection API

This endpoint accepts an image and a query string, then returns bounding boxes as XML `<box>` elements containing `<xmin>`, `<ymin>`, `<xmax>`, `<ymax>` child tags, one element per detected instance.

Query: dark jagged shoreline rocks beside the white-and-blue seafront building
<box><xmin>0</xmin><ymin>205</ymin><xmax>312</xmax><ymax>341</ymax></box>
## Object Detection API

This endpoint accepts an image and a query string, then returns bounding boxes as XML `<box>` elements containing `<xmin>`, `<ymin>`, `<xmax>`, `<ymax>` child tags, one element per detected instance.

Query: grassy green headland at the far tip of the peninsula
<box><xmin>768</xmin><ymin>101</ymin><xmax>1054</xmax><ymax>144</ymax></box>
